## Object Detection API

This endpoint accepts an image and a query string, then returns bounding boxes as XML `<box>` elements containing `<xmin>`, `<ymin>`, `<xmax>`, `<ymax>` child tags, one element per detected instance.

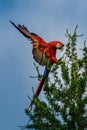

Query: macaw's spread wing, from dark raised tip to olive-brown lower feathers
<box><xmin>10</xmin><ymin>21</ymin><xmax>49</xmax><ymax>65</ymax></box>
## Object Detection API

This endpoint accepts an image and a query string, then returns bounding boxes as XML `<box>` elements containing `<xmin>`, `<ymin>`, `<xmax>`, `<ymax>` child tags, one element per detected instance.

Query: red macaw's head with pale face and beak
<box><xmin>49</xmin><ymin>41</ymin><xmax>64</xmax><ymax>51</ymax></box>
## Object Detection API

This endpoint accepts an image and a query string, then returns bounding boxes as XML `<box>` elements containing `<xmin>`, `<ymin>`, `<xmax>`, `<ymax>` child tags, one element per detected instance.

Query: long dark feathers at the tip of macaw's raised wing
<box><xmin>10</xmin><ymin>21</ymin><xmax>35</xmax><ymax>41</ymax></box>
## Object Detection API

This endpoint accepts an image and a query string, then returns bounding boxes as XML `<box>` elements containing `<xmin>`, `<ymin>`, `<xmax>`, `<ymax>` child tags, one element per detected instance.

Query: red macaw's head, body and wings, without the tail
<box><xmin>10</xmin><ymin>21</ymin><xmax>64</xmax><ymax>65</ymax></box>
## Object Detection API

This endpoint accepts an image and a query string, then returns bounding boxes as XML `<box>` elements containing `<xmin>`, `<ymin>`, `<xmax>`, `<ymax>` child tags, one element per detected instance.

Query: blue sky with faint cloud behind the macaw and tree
<box><xmin>0</xmin><ymin>0</ymin><xmax>87</xmax><ymax>130</ymax></box>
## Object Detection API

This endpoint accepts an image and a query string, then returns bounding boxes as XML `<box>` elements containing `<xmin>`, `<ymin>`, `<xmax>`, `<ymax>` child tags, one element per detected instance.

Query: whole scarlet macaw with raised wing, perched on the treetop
<box><xmin>10</xmin><ymin>21</ymin><xmax>64</xmax><ymax>109</ymax></box>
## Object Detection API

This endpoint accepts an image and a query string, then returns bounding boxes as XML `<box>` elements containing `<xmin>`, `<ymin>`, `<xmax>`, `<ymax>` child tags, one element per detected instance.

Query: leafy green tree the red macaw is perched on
<box><xmin>23</xmin><ymin>26</ymin><xmax>87</xmax><ymax>130</ymax></box>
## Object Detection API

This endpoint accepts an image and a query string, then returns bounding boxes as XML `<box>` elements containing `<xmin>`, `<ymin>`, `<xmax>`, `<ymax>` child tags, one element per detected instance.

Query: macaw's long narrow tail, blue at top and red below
<box><xmin>29</xmin><ymin>68</ymin><xmax>49</xmax><ymax>110</ymax></box>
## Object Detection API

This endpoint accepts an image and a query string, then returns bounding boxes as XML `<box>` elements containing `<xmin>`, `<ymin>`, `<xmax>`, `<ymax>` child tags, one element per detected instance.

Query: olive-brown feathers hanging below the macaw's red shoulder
<box><xmin>32</xmin><ymin>47</ymin><xmax>50</xmax><ymax>66</ymax></box>
